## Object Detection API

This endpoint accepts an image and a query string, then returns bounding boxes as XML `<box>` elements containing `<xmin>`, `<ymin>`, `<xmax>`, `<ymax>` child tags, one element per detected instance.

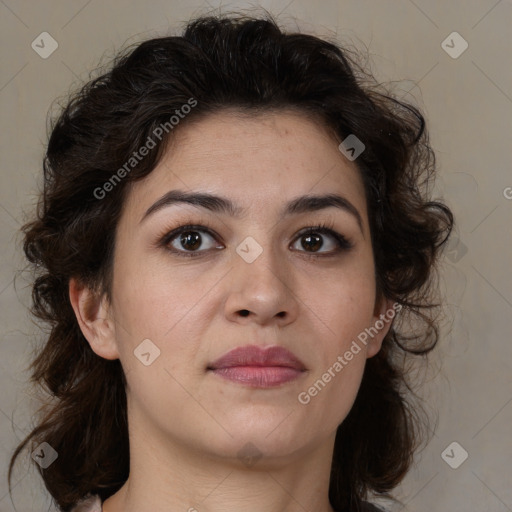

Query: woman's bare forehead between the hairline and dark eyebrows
<box><xmin>122</xmin><ymin>110</ymin><xmax>366</xmax><ymax>225</ymax></box>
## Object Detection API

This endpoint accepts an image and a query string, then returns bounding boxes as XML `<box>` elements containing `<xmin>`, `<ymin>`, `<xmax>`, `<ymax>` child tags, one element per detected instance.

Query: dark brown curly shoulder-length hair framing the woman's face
<box><xmin>8</xmin><ymin>13</ymin><xmax>453</xmax><ymax>511</ymax></box>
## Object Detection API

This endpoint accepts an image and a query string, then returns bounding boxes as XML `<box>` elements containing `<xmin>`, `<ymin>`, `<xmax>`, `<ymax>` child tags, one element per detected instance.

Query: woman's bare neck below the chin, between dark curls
<box><xmin>103</xmin><ymin>416</ymin><xmax>335</xmax><ymax>512</ymax></box>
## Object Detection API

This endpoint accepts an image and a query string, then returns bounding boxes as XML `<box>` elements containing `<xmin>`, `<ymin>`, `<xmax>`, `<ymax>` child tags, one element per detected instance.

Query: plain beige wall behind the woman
<box><xmin>0</xmin><ymin>0</ymin><xmax>512</xmax><ymax>512</ymax></box>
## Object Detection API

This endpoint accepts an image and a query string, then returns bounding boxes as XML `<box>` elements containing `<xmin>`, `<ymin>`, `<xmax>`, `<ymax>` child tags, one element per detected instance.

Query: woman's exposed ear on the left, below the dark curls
<box><xmin>69</xmin><ymin>278</ymin><xmax>119</xmax><ymax>359</ymax></box>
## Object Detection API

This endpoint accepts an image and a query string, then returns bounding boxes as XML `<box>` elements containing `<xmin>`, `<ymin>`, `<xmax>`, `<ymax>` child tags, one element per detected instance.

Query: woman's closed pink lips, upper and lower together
<box><xmin>208</xmin><ymin>345</ymin><xmax>306</xmax><ymax>388</ymax></box>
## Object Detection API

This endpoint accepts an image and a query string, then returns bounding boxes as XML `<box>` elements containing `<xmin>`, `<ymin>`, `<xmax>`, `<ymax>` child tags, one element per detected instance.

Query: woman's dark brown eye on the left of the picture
<box><xmin>162</xmin><ymin>225</ymin><xmax>224</xmax><ymax>256</ymax></box>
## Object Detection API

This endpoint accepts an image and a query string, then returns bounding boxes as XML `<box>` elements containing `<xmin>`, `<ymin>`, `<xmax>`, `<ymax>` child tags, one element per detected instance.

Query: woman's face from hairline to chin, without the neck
<box><xmin>75</xmin><ymin>112</ymin><xmax>389</xmax><ymax>464</ymax></box>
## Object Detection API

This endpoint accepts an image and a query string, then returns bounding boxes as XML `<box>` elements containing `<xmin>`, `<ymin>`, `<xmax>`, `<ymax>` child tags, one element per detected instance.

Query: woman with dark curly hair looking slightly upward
<box><xmin>9</xmin><ymin>11</ymin><xmax>453</xmax><ymax>512</ymax></box>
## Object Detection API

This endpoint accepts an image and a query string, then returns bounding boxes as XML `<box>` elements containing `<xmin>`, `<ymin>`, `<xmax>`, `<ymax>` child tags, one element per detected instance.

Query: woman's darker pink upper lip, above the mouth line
<box><xmin>208</xmin><ymin>345</ymin><xmax>306</xmax><ymax>371</ymax></box>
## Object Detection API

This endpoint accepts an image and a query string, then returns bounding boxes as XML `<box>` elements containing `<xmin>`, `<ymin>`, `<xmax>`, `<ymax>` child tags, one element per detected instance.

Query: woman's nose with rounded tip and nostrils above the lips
<box><xmin>225</xmin><ymin>238</ymin><xmax>300</xmax><ymax>327</ymax></box>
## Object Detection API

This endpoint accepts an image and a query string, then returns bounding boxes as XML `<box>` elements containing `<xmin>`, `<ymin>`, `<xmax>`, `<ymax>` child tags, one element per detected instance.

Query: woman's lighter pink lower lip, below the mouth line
<box><xmin>212</xmin><ymin>366</ymin><xmax>302</xmax><ymax>388</ymax></box>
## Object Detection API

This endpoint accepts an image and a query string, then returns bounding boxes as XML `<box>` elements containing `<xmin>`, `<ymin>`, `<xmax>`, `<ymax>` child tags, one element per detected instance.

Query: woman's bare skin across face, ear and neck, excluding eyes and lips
<box><xmin>69</xmin><ymin>111</ymin><xmax>391</xmax><ymax>512</ymax></box>
